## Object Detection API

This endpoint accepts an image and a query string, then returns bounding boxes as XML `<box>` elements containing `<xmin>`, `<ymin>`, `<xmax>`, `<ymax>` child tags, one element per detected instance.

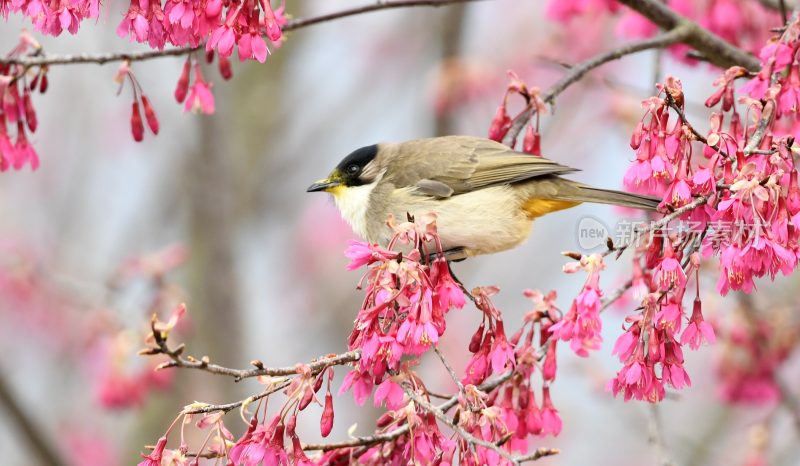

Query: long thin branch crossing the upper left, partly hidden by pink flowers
<box><xmin>0</xmin><ymin>0</ymin><xmax>483</xmax><ymax>68</ymax></box>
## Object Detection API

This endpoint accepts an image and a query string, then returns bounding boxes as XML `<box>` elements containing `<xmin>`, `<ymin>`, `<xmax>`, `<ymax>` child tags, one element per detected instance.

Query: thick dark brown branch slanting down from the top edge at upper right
<box><xmin>619</xmin><ymin>0</ymin><xmax>761</xmax><ymax>71</ymax></box>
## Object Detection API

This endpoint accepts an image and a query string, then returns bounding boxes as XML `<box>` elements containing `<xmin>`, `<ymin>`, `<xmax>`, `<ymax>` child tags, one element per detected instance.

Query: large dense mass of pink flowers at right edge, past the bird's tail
<box><xmin>610</xmin><ymin>22</ymin><xmax>800</xmax><ymax>401</ymax></box>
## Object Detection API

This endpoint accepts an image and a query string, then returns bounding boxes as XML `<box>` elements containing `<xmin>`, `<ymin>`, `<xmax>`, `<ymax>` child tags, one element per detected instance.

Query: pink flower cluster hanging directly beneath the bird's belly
<box><xmin>342</xmin><ymin>214</ymin><xmax>465</xmax><ymax>404</ymax></box>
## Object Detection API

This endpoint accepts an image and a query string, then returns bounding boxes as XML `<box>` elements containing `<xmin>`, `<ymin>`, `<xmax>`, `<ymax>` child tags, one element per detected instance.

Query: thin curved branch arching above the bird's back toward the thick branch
<box><xmin>503</xmin><ymin>27</ymin><xmax>689</xmax><ymax>146</ymax></box>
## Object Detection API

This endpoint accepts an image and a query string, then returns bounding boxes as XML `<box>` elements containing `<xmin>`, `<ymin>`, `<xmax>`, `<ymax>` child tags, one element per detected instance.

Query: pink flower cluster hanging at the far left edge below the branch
<box><xmin>0</xmin><ymin>32</ymin><xmax>42</xmax><ymax>172</ymax></box>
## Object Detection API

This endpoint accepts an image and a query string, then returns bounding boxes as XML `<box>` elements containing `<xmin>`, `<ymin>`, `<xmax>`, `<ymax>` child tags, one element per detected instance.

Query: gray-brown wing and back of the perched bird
<box><xmin>382</xmin><ymin>136</ymin><xmax>577</xmax><ymax>197</ymax></box>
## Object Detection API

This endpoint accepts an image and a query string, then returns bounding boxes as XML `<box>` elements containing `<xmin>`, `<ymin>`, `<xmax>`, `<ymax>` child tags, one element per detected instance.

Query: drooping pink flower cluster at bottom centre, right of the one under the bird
<box><xmin>459</xmin><ymin>288</ymin><xmax>561</xmax><ymax>458</ymax></box>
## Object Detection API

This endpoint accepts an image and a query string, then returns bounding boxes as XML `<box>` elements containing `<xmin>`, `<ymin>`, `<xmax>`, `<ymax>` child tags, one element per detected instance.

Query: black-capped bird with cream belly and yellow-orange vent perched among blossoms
<box><xmin>307</xmin><ymin>136</ymin><xmax>660</xmax><ymax>260</ymax></box>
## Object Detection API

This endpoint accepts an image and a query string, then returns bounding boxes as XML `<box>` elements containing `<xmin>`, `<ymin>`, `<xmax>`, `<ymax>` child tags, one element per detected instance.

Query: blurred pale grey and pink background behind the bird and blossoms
<box><xmin>0</xmin><ymin>0</ymin><xmax>800</xmax><ymax>466</ymax></box>
